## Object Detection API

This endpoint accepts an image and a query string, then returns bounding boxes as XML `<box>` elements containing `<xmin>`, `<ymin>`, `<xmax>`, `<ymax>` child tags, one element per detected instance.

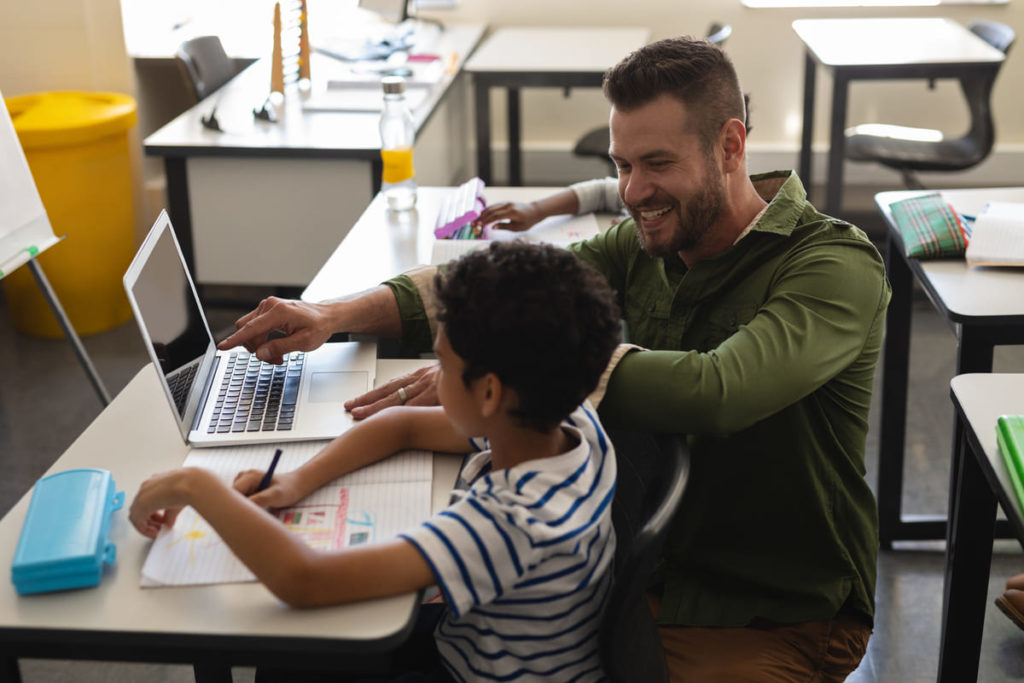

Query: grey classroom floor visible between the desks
<box><xmin>0</xmin><ymin>266</ymin><xmax>1024</xmax><ymax>683</ymax></box>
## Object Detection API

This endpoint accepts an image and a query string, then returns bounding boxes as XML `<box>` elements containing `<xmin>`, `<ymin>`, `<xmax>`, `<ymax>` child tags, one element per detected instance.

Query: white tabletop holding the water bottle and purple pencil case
<box><xmin>302</xmin><ymin>187</ymin><xmax>608</xmax><ymax>301</ymax></box>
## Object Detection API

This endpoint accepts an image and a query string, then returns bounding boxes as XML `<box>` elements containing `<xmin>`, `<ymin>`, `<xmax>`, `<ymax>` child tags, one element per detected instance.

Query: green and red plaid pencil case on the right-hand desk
<box><xmin>889</xmin><ymin>193</ymin><xmax>967</xmax><ymax>258</ymax></box>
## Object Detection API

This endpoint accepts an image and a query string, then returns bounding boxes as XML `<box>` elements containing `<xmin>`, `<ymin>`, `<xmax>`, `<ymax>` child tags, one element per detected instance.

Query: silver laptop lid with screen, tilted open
<box><xmin>124</xmin><ymin>211</ymin><xmax>217</xmax><ymax>442</ymax></box>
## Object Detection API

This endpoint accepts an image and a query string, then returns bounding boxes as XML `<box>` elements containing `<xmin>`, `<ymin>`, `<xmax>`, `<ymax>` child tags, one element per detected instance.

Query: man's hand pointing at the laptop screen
<box><xmin>217</xmin><ymin>297</ymin><xmax>337</xmax><ymax>365</ymax></box>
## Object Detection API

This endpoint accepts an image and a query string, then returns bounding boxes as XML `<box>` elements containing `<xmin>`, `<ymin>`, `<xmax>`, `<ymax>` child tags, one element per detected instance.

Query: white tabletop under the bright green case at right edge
<box><xmin>949</xmin><ymin>373</ymin><xmax>1024</xmax><ymax>528</ymax></box>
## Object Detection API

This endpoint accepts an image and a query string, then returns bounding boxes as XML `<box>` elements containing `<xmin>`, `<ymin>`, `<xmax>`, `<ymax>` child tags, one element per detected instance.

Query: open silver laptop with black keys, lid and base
<box><xmin>124</xmin><ymin>211</ymin><xmax>377</xmax><ymax>446</ymax></box>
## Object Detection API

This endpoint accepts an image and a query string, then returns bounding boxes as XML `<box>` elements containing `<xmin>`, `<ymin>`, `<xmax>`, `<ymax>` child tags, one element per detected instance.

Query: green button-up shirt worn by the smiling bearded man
<box><xmin>389</xmin><ymin>172</ymin><xmax>890</xmax><ymax>627</ymax></box>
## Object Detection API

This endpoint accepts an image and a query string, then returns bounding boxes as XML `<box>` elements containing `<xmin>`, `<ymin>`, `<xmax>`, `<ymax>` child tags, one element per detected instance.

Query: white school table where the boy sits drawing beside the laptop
<box><xmin>0</xmin><ymin>360</ymin><xmax>461</xmax><ymax>683</ymax></box>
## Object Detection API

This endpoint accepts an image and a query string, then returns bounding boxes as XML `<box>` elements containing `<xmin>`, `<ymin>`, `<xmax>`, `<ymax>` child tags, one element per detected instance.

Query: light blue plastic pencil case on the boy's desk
<box><xmin>10</xmin><ymin>469</ymin><xmax>125</xmax><ymax>595</ymax></box>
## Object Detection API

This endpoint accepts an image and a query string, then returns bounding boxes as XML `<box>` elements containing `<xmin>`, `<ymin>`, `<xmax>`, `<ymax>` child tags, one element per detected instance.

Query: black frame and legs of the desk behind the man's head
<box><xmin>471</xmin><ymin>71</ymin><xmax>604</xmax><ymax>187</ymax></box>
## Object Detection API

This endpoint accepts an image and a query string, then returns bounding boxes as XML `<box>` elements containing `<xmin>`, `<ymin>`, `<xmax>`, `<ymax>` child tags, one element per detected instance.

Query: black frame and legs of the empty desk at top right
<box><xmin>799</xmin><ymin>52</ymin><xmax>1001</xmax><ymax>216</ymax></box>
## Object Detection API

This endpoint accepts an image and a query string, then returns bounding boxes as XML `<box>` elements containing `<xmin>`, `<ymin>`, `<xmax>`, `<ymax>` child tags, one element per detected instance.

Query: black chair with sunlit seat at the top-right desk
<box><xmin>845</xmin><ymin>20</ymin><xmax>1017</xmax><ymax>189</ymax></box>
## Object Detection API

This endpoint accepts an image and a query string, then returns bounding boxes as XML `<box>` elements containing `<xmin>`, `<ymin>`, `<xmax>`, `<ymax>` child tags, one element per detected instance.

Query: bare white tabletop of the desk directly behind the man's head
<box><xmin>466</xmin><ymin>27</ymin><xmax>650</xmax><ymax>73</ymax></box>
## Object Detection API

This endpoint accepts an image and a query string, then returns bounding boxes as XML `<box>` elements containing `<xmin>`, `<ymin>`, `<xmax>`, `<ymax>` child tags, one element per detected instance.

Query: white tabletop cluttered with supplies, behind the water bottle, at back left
<box><xmin>145</xmin><ymin>24</ymin><xmax>483</xmax><ymax>154</ymax></box>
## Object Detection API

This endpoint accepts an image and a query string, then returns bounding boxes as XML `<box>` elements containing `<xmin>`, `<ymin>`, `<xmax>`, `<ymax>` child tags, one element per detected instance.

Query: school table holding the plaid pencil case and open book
<box><xmin>874</xmin><ymin>187</ymin><xmax>1024</xmax><ymax>548</ymax></box>
